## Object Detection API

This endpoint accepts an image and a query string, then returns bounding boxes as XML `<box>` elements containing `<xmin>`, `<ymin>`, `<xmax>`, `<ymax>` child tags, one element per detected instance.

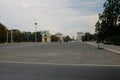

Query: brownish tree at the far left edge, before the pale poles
<box><xmin>0</xmin><ymin>23</ymin><xmax>8</xmax><ymax>43</ymax></box>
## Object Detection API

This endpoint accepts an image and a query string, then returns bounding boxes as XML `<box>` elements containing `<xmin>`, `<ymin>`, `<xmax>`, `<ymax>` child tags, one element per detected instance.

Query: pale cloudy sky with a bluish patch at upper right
<box><xmin>0</xmin><ymin>0</ymin><xmax>105</xmax><ymax>37</ymax></box>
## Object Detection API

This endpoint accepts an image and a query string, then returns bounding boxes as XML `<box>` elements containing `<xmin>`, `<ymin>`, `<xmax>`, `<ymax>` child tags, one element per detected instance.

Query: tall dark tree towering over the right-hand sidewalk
<box><xmin>95</xmin><ymin>0</ymin><xmax>120</xmax><ymax>40</ymax></box>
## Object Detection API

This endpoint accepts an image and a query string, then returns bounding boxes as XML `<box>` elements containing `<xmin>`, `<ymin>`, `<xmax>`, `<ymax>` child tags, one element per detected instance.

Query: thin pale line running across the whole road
<box><xmin>0</xmin><ymin>61</ymin><xmax>120</xmax><ymax>67</ymax></box>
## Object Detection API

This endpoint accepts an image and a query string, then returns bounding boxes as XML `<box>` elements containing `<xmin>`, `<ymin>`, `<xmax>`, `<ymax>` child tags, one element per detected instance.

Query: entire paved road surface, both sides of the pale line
<box><xmin>0</xmin><ymin>43</ymin><xmax>120</xmax><ymax>80</ymax></box>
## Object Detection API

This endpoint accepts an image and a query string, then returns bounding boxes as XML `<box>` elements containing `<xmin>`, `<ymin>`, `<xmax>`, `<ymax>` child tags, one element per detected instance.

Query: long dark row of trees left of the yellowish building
<box><xmin>0</xmin><ymin>23</ymin><xmax>42</xmax><ymax>43</ymax></box>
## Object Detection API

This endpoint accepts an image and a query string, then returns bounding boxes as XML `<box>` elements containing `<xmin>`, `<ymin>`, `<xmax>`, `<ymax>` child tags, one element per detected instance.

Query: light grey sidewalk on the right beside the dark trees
<box><xmin>85</xmin><ymin>42</ymin><xmax>120</xmax><ymax>55</ymax></box>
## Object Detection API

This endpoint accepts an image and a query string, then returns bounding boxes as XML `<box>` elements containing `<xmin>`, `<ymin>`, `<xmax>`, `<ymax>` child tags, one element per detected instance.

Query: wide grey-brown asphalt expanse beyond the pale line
<box><xmin>0</xmin><ymin>43</ymin><xmax>120</xmax><ymax>65</ymax></box>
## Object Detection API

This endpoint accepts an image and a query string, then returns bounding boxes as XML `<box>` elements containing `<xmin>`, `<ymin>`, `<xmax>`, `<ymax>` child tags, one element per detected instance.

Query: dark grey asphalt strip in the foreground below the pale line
<box><xmin>0</xmin><ymin>62</ymin><xmax>120</xmax><ymax>80</ymax></box>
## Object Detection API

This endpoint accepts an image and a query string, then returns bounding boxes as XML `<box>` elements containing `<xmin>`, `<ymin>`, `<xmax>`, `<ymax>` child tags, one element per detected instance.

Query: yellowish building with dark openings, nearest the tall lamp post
<box><xmin>40</xmin><ymin>30</ymin><xmax>51</xmax><ymax>42</ymax></box>
